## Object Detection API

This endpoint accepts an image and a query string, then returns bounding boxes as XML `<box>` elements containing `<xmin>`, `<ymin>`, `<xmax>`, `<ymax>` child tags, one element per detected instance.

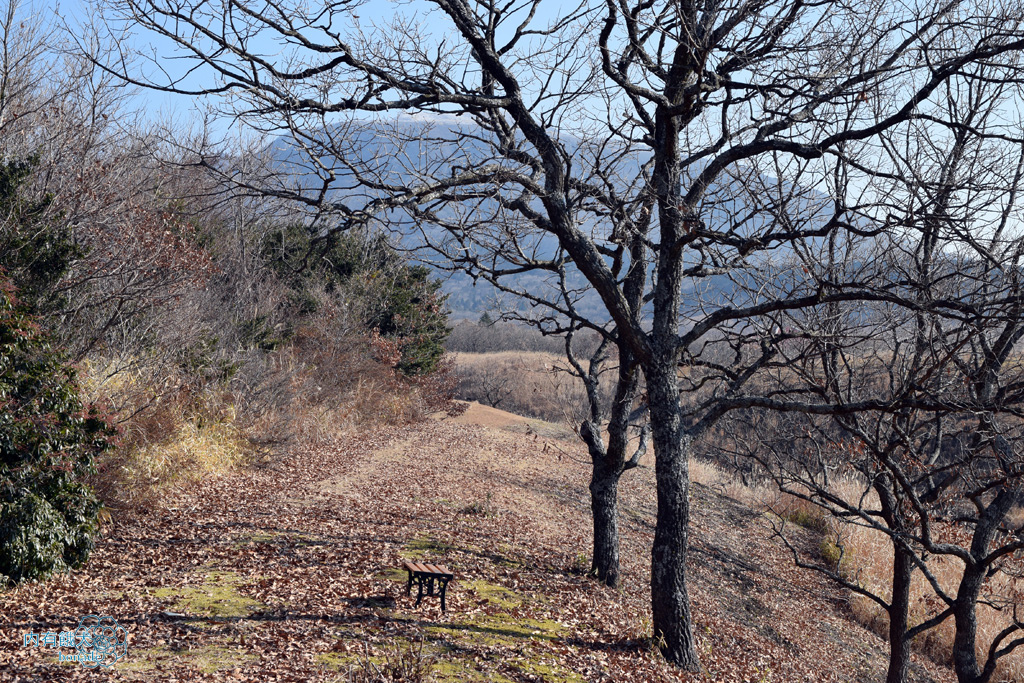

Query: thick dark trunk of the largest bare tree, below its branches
<box><xmin>645</xmin><ymin>362</ymin><xmax>700</xmax><ymax>671</ymax></box>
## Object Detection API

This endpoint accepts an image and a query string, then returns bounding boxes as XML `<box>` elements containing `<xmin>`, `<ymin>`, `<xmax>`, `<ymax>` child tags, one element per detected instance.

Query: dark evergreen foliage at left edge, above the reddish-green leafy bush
<box><xmin>0</xmin><ymin>159</ymin><xmax>85</xmax><ymax>314</ymax></box>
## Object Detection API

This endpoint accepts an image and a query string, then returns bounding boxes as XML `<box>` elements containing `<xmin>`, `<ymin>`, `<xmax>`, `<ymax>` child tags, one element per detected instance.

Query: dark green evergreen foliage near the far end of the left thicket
<box><xmin>263</xmin><ymin>225</ymin><xmax>450</xmax><ymax>376</ymax></box>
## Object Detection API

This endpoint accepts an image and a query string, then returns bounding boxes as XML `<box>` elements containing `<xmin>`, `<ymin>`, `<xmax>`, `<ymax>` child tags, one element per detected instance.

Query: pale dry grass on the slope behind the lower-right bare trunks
<box><xmin>690</xmin><ymin>459</ymin><xmax>1024</xmax><ymax>683</ymax></box>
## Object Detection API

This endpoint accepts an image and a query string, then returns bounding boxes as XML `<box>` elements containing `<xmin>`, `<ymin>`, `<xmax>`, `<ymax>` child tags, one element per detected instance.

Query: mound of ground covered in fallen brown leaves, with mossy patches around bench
<box><xmin>0</xmin><ymin>407</ymin><xmax>953</xmax><ymax>683</ymax></box>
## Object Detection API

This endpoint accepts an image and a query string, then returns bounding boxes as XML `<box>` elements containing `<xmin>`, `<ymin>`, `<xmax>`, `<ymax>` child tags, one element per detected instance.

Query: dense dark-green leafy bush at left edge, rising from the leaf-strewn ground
<box><xmin>0</xmin><ymin>273</ymin><xmax>114</xmax><ymax>584</ymax></box>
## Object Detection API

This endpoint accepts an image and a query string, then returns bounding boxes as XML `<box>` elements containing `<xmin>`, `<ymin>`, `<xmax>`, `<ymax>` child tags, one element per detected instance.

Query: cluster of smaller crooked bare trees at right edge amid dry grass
<box><xmin>724</xmin><ymin>65</ymin><xmax>1024</xmax><ymax>683</ymax></box>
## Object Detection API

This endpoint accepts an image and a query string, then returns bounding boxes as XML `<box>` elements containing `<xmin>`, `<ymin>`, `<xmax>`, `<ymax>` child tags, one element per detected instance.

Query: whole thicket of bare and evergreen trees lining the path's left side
<box><xmin>0</xmin><ymin>10</ymin><xmax>454</xmax><ymax>583</ymax></box>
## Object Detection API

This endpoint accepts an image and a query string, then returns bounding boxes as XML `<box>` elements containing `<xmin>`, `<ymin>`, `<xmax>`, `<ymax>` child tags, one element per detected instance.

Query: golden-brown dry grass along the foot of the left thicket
<box><xmin>79</xmin><ymin>326</ymin><xmax>443</xmax><ymax>507</ymax></box>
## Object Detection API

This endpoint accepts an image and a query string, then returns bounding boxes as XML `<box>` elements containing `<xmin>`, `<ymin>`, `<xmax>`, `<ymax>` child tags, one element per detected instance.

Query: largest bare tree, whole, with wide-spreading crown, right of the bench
<box><xmin>88</xmin><ymin>0</ymin><xmax>1024</xmax><ymax>670</ymax></box>
